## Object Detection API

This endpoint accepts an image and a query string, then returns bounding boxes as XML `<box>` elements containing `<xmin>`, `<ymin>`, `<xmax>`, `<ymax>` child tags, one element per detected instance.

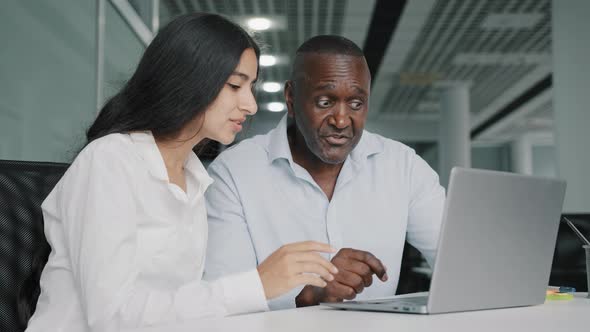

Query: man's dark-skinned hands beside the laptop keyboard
<box><xmin>295</xmin><ymin>248</ymin><xmax>387</xmax><ymax>307</ymax></box>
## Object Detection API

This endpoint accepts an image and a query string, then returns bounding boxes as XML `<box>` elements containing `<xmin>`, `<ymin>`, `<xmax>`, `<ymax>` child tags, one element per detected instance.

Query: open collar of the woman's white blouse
<box><xmin>129</xmin><ymin>131</ymin><xmax>213</xmax><ymax>191</ymax></box>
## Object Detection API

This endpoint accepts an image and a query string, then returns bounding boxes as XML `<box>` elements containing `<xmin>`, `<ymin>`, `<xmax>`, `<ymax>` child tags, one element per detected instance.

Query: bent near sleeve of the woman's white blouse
<box><xmin>57</xmin><ymin>142</ymin><xmax>268</xmax><ymax>331</ymax></box>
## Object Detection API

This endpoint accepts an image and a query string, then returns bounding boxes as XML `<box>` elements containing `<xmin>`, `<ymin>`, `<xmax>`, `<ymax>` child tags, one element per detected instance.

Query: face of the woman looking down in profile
<box><xmin>201</xmin><ymin>48</ymin><xmax>258</xmax><ymax>144</ymax></box>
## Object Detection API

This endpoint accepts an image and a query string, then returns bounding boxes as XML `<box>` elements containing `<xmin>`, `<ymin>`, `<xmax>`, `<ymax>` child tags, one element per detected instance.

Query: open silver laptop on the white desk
<box><xmin>322</xmin><ymin>168</ymin><xmax>566</xmax><ymax>314</ymax></box>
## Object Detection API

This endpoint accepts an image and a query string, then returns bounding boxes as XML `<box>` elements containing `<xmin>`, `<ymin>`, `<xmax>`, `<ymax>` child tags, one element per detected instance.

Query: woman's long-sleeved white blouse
<box><xmin>27</xmin><ymin>132</ymin><xmax>268</xmax><ymax>331</ymax></box>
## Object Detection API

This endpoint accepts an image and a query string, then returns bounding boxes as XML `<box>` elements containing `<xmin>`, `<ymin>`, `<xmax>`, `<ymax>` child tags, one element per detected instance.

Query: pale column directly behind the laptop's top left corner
<box><xmin>439</xmin><ymin>83</ymin><xmax>471</xmax><ymax>187</ymax></box>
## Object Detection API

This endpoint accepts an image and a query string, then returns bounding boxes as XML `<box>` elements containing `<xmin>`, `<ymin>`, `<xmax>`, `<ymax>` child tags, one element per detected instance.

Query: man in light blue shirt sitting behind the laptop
<box><xmin>205</xmin><ymin>36</ymin><xmax>444</xmax><ymax>309</ymax></box>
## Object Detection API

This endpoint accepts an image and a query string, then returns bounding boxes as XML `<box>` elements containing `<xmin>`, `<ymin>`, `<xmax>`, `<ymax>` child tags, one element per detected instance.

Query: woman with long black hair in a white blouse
<box><xmin>27</xmin><ymin>14</ymin><xmax>337</xmax><ymax>331</ymax></box>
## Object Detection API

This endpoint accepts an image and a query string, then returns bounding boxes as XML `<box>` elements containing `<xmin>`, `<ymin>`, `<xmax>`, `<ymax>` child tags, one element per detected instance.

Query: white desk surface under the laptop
<box><xmin>126</xmin><ymin>293</ymin><xmax>590</xmax><ymax>332</ymax></box>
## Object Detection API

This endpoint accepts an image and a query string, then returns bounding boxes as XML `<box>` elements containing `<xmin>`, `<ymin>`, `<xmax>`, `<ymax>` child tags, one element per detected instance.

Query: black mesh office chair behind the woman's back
<box><xmin>0</xmin><ymin>160</ymin><xmax>69</xmax><ymax>332</ymax></box>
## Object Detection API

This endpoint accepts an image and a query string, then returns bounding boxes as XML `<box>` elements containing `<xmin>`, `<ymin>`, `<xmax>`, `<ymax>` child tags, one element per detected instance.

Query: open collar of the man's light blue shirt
<box><xmin>268</xmin><ymin>114</ymin><xmax>384</xmax><ymax>165</ymax></box>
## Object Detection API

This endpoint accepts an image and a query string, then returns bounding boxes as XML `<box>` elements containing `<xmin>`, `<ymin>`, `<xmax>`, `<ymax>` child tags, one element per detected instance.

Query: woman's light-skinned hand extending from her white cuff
<box><xmin>258</xmin><ymin>241</ymin><xmax>338</xmax><ymax>299</ymax></box>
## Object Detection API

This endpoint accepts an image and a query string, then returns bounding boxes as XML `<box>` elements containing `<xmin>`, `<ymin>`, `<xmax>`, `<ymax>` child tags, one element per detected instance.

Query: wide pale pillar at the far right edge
<box><xmin>552</xmin><ymin>0</ymin><xmax>590</xmax><ymax>213</ymax></box>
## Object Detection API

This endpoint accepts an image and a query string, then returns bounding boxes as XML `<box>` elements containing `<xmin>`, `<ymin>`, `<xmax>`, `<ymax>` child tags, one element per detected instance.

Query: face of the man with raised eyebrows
<box><xmin>285</xmin><ymin>53</ymin><xmax>371</xmax><ymax>164</ymax></box>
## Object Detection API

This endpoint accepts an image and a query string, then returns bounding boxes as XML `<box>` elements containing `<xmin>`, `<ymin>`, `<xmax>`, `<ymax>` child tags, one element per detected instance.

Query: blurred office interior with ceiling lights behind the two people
<box><xmin>0</xmin><ymin>0</ymin><xmax>590</xmax><ymax>304</ymax></box>
